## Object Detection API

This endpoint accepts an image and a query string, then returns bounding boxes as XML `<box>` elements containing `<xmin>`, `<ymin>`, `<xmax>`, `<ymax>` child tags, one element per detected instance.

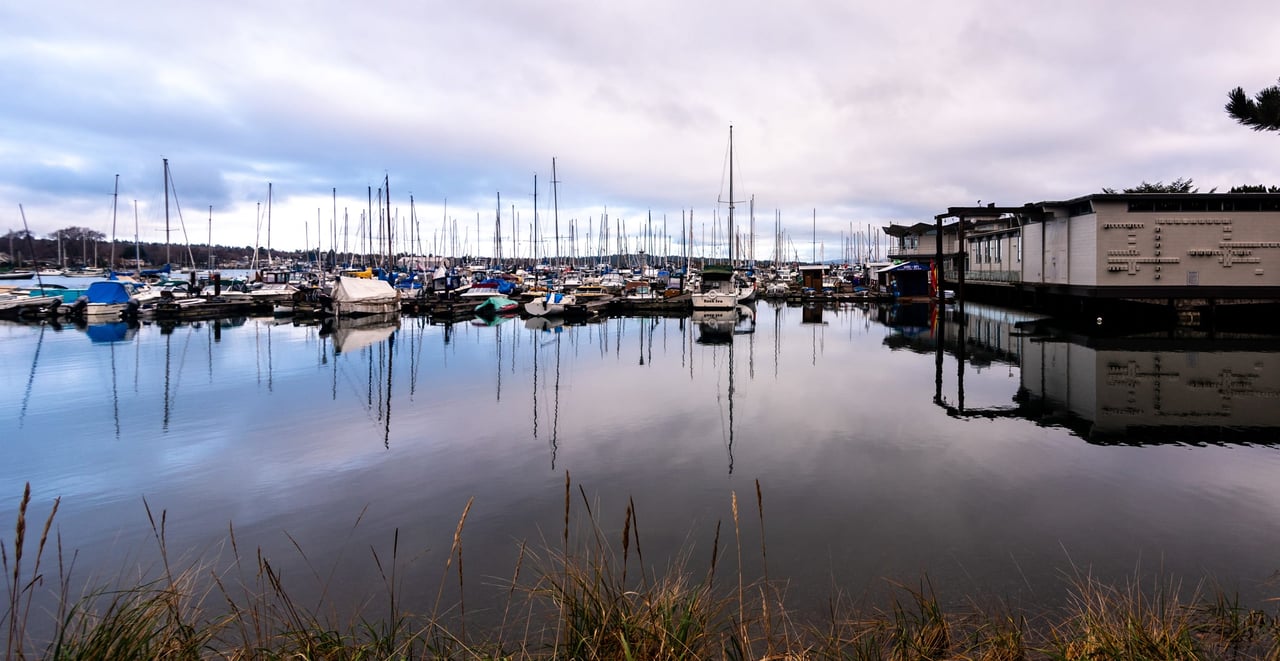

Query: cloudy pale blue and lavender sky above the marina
<box><xmin>0</xmin><ymin>0</ymin><xmax>1280</xmax><ymax>260</ymax></box>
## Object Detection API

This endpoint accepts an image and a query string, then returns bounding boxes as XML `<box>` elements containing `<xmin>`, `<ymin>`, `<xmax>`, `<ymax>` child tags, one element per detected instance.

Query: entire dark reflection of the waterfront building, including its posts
<box><xmin>901</xmin><ymin>304</ymin><xmax>1280</xmax><ymax>446</ymax></box>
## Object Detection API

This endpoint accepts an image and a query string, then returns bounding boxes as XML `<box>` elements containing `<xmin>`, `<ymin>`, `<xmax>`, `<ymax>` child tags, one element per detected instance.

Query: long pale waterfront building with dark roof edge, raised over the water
<box><xmin>884</xmin><ymin>193</ymin><xmax>1280</xmax><ymax>324</ymax></box>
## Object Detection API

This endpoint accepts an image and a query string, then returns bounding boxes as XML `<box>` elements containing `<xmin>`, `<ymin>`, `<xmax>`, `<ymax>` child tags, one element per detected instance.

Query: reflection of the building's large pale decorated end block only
<box><xmin>1016</xmin><ymin>337</ymin><xmax>1280</xmax><ymax>445</ymax></box>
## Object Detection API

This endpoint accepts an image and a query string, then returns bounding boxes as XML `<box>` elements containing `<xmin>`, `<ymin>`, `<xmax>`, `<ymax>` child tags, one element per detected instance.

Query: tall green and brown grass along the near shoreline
<box><xmin>0</xmin><ymin>474</ymin><xmax>1280</xmax><ymax>661</ymax></box>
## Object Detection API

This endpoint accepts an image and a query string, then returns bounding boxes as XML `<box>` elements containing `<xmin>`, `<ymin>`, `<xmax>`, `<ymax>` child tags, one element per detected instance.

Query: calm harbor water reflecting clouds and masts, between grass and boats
<box><xmin>0</xmin><ymin>295</ymin><xmax>1280</xmax><ymax>625</ymax></box>
